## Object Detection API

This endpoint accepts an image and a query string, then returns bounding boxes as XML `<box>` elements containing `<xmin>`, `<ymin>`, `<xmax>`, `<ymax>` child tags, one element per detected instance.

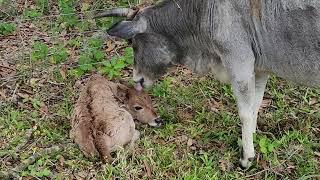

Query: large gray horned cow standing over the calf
<box><xmin>97</xmin><ymin>0</ymin><xmax>320</xmax><ymax>167</ymax></box>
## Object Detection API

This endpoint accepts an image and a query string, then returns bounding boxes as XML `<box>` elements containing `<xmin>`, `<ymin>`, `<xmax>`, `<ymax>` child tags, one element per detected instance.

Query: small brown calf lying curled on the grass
<box><xmin>70</xmin><ymin>75</ymin><xmax>162</xmax><ymax>162</ymax></box>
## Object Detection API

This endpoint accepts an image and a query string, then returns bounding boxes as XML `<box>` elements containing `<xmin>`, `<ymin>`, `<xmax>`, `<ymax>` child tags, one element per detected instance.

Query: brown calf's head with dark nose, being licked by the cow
<box><xmin>118</xmin><ymin>85</ymin><xmax>163</xmax><ymax>127</ymax></box>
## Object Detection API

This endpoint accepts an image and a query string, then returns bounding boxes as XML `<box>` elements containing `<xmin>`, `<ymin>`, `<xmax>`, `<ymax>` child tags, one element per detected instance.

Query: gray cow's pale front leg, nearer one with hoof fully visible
<box><xmin>226</xmin><ymin>55</ymin><xmax>256</xmax><ymax>167</ymax></box>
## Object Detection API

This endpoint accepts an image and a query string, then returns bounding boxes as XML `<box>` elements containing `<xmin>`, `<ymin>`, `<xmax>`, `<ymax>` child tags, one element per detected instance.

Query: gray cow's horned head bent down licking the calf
<box><xmin>96</xmin><ymin>8</ymin><xmax>178</xmax><ymax>86</ymax></box>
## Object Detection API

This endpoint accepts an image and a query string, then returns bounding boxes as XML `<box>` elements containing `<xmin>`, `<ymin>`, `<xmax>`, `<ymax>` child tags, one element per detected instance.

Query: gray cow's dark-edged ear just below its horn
<box><xmin>108</xmin><ymin>21</ymin><xmax>147</xmax><ymax>39</ymax></box>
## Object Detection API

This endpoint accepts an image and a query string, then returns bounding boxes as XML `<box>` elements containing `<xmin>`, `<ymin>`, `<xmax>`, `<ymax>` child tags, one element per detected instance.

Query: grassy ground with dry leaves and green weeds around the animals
<box><xmin>0</xmin><ymin>0</ymin><xmax>320</xmax><ymax>180</ymax></box>
